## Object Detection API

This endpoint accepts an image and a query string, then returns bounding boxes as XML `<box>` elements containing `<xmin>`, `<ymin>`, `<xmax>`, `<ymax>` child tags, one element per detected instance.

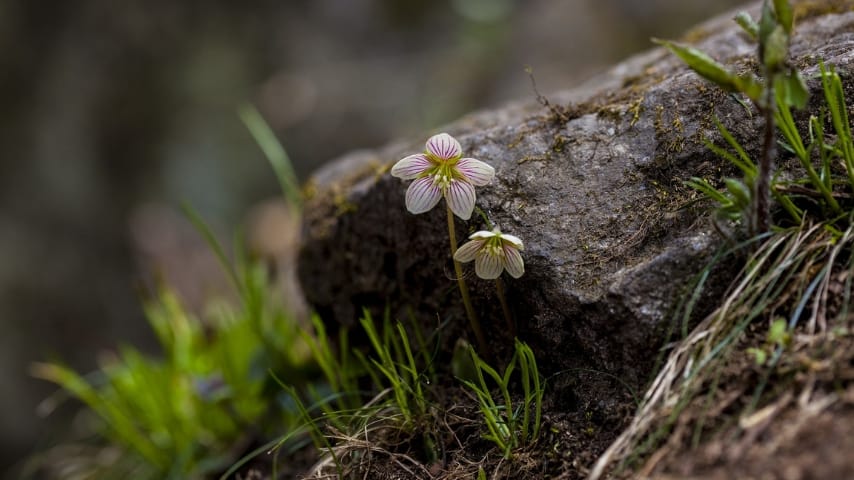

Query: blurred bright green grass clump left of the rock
<box><xmin>34</xmin><ymin>265</ymin><xmax>310</xmax><ymax>479</ymax></box>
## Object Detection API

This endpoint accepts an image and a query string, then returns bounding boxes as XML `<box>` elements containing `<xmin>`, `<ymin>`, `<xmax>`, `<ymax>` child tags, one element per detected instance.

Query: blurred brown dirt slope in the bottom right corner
<box><xmin>639</xmin><ymin>329</ymin><xmax>854</xmax><ymax>480</ymax></box>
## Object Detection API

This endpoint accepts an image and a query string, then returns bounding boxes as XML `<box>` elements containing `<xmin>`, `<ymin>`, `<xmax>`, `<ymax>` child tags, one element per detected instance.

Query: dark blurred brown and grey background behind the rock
<box><xmin>0</xmin><ymin>0</ymin><xmax>736</xmax><ymax>471</ymax></box>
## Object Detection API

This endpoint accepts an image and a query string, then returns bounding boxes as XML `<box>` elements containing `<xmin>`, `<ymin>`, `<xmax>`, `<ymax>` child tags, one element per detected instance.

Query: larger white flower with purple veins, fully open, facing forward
<box><xmin>391</xmin><ymin>133</ymin><xmax>495</xmax><ymax>220</ymax></box>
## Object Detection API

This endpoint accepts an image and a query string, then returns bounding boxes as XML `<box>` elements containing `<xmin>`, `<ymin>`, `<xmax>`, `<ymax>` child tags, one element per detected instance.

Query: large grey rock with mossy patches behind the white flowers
<box><xmin>299</xmin><ymin>2</ymin><xmax>854</xmax><ymax>384</ymax></box>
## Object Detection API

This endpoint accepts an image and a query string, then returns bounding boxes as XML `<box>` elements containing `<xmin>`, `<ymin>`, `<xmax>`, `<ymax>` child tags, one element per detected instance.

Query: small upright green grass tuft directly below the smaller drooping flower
<box><xmin>461</xmin><ymin>340</ymin><xmax>545</xmax><ymax>458</ymax></box>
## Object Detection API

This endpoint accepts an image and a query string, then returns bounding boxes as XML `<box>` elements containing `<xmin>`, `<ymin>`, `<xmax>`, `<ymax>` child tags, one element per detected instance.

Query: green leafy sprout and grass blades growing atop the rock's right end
<box><xmin>684</xmin><ymin>1</ymin><xmax>854</xmax><ymax>230</ymax></box>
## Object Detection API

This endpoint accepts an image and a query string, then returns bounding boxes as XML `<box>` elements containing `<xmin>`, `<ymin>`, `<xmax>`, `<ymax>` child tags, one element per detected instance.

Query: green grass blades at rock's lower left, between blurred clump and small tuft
<box><xmin>258</xmin><ymin>310</ymin><xmax>438</xmax><ymax>477</ymax></box>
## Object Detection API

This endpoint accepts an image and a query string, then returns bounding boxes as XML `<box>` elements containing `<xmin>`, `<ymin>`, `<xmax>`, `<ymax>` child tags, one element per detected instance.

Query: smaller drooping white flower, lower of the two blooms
<box><xmin>454</xmin><ymin>227</ymin><xmax>525</xmax><ymax>280</ymax></box>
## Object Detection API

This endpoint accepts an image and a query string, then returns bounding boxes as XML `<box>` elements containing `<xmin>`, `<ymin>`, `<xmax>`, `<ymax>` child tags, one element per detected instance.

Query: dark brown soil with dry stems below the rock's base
<box><xmin>254</xmin><ymin>350</ymin><xmax>635</xmax><ymax>480</ymax></box>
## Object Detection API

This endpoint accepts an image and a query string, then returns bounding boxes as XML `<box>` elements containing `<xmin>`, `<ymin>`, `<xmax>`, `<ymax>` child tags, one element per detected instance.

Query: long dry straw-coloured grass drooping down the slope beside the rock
<box><xmin>590</xmin><ymin>217</ymin><xmax>854</xmax><ymax>479</ymax></box>
